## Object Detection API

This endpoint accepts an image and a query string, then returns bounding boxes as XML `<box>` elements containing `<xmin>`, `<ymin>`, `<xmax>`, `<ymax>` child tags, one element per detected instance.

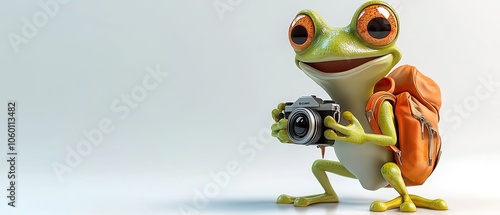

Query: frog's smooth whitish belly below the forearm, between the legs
<box><xmin>334</xmin><ymin>141</ymin><xmax>393</xmax><ymax>190</ymax></box>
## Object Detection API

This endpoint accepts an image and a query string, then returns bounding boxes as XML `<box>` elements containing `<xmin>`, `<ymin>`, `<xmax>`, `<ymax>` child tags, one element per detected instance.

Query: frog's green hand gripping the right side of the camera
<box><xmin>324</xmin><ymin>111</ymin><xmax>366</xmax><ymax>144</ymax></box>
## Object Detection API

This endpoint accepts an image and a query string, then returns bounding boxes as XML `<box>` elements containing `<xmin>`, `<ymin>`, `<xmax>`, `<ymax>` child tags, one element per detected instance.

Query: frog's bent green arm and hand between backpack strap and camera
<box><xmin>324</xmin><ymin>101</ymin><xmax>397</xmax><ymax>146</ymax></box>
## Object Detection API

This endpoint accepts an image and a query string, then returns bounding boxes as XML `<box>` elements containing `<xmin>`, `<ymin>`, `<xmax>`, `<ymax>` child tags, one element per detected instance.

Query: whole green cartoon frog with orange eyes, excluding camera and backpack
<box><xmin>272</xmin><ymin>1</ymin><xmax>448</xmax><ymax>212</ymax></box>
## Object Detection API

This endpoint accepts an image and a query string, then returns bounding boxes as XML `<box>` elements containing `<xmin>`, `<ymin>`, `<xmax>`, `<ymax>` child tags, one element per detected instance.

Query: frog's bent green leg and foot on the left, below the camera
<box><xmin>276</xmin><ymin>159</ymin><xmax>356</xmax><ymax>207</ymax></box>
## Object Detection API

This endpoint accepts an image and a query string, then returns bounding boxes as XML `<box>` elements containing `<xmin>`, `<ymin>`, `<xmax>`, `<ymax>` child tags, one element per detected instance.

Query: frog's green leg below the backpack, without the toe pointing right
<box><xmin>370</xmin><ymin>162</ymin><xmax>420</xmax><ymax>212</ymax></box>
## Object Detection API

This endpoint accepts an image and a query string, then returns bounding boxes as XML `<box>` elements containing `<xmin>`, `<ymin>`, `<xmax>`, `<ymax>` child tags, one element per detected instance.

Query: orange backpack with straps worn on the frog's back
<box><xmin>366</xmin><ymin>65</ymin><xmax>441</xmax><ymax>186</ymax></box>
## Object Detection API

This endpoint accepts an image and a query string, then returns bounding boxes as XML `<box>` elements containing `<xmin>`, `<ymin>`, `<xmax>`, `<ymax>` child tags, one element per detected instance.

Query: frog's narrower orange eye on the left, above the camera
<box><xmin>288</xmin><ymin>14</ymin><xmax>314</xmax><ymax>51</ymax></box>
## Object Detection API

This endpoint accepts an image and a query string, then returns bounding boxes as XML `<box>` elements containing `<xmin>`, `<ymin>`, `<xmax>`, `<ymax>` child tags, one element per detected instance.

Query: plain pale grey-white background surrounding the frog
<box><xmin>0</xmin><ymin>0</ymin><xmax>500</xmax><ymax>214</ymax></box>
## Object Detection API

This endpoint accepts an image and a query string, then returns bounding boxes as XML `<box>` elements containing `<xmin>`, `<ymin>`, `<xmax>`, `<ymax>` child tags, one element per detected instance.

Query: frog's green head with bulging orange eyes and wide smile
<box><xmin>288</xmin><ymin>1</ymin><xmax>401</xmax><ymax>107</ymax></box>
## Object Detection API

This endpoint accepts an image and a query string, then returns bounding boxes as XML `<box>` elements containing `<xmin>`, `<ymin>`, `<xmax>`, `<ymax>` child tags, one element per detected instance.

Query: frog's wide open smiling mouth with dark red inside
<box><xmin>303</xmin><ymin>56</ymin><xmax>381</xmax><ymax>73</ymax></box>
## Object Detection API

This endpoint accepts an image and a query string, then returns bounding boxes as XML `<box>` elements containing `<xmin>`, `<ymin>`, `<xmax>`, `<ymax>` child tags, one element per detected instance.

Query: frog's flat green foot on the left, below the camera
<box><xmin>276</xmin><ymin>193</ymin><xmax>339</xmax><ymax>207</ymax></box>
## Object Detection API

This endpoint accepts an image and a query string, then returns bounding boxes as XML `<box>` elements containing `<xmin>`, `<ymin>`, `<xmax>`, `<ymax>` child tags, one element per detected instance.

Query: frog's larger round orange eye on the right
<box><xmin>356</xmin><ymin>5</ymin><xmax>399</xmax><ymax>46</ymax></box>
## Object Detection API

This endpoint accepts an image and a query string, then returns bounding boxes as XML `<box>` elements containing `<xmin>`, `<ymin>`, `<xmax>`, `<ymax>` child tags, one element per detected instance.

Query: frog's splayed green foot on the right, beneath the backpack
<box><xmin>370</xmin><ymin>195</ymin><xmax>448</xmax><ymax>212</ymax></box>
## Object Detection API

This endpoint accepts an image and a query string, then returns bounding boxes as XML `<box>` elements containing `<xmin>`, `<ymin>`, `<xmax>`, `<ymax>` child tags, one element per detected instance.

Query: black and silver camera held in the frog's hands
<box><xmin>284</xmin><ymin>95</ymin><xmax>340</xmax><ymax>146</ymax></box>
